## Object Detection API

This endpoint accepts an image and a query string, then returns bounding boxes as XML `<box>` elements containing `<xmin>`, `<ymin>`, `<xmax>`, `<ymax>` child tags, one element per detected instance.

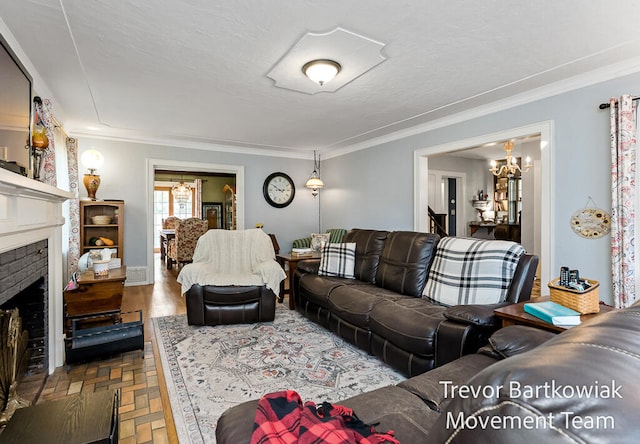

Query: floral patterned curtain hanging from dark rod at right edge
<box><xmin>610</xmin><ymin>95</ymin><xmax>636</xmax><ymax>308</ymax></box>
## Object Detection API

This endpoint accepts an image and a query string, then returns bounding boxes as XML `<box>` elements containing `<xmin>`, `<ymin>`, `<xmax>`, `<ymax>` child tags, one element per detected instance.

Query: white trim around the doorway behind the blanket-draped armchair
<box><xmin>146</xmin><ymin>158</ymin><xmax>245</xmax><ymax>284</ymax></box>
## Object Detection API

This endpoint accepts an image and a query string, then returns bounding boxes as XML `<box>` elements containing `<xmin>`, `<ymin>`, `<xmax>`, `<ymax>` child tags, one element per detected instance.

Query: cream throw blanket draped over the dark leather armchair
<box><xmin>178</xmin><ymin>228</ymin><xmax>286</xmax><ymax>296</ymax></box>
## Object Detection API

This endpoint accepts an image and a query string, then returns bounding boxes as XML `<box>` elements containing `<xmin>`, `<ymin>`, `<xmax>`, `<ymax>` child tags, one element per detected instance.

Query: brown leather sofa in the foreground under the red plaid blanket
<box><xmin>216</xmin><ymin>303</ymin><xmax>640</xmax><ymax>444</ymax></box>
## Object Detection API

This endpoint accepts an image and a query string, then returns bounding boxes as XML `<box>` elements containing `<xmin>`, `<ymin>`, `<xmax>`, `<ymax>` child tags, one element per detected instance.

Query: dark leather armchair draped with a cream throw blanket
<box><xmin>178</xmin><ymin>229</ymin><xmax>286</xmax><ymax>325</ymax></box>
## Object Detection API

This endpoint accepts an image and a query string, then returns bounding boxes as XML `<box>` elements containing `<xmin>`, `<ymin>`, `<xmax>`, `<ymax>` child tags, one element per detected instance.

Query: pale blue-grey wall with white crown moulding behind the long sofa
<box><xmin>323</xmin><ymin>74</ymin><xmax>640</xmax><ymax>302</ymax></box>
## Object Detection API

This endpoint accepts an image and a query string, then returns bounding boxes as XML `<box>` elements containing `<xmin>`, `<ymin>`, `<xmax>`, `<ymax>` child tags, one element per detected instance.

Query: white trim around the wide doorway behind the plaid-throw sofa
<box><xmin>413</xmin><ymin>120</ymin><xmax>556</xmax><ymax>288</ymax></box>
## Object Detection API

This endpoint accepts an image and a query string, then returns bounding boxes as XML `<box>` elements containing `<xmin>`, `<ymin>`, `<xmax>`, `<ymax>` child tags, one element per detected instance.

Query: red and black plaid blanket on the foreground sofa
<box><xmin>251</xmin><ymin>390</ymin><xmax>400</xmax><ymax>444</ymax></box>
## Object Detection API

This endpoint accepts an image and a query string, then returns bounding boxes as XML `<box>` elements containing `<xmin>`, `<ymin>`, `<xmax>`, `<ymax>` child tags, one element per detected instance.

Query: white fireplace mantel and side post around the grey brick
<box><xmin>0</xmin><ymin>169</ymin><xmax>74</xmax><ymax>374</ymax></box>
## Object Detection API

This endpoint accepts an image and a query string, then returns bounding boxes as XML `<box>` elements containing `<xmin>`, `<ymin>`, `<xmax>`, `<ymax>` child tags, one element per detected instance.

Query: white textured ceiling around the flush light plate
<box><xmin>0</xmin><ymin>0</ymin><xmax>640</xmax><ymax>156</ymax></box>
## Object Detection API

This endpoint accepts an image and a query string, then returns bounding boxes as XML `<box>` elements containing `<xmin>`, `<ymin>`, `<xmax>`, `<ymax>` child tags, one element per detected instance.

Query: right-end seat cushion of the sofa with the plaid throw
<box><xmin>369</xmin><ymin>297</ymin><xmax>446</xmax><ymax>356</ymax></box>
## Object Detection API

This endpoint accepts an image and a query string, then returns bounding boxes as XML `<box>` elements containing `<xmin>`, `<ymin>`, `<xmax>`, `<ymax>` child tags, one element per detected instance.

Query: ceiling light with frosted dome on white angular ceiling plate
<box><xmin>267</xmin><ymin>28</ymin><xmax>385</xmax><ymax>94</ymax></box>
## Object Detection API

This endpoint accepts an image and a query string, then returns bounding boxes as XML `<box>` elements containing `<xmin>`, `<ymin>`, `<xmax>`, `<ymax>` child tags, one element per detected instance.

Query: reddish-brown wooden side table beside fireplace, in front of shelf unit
<box><xmin>64</xmin><ymin>266</ymin><xmax>127</xmax><ymax>336</ymax></box>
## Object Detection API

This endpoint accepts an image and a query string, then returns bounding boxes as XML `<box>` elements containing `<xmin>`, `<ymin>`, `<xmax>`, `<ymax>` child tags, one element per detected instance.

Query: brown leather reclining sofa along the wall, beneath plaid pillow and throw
<box><xmin>294</xmin><ymin>229</ymin><xmax>538</xmax><ymax>376</ymax></box>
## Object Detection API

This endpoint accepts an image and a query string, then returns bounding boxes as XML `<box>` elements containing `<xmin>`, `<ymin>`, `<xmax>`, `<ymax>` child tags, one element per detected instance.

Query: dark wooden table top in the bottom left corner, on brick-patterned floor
<box><xmin>0</xmin><ymin>390</ymin><xmax>119</xmax><ymax>444</ymax></box>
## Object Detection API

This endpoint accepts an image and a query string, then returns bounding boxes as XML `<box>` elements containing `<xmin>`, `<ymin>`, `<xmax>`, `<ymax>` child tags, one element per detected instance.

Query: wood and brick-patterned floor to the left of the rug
<box><xmin>37</xmin><ymin>255</ymin><xmax>186</xmax><ymax>444</ymax></box>
